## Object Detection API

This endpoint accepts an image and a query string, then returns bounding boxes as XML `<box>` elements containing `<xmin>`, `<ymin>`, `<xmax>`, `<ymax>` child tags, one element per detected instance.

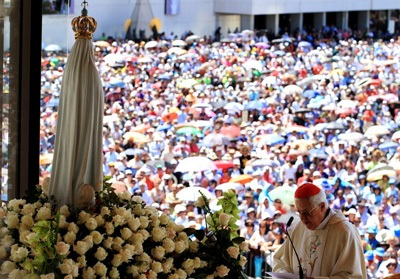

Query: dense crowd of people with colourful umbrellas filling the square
<box><xmin>40</xmin><ymin>30</ymin><xmax>400</xmax><ymax>278</ymax></box>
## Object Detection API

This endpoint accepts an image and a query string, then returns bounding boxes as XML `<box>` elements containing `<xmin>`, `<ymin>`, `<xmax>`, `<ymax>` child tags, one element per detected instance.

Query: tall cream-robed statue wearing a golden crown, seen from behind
<box><xmin>49</xmin><ymin>6</ymin><xmax>104</xmax><ymax>207</ymax></box>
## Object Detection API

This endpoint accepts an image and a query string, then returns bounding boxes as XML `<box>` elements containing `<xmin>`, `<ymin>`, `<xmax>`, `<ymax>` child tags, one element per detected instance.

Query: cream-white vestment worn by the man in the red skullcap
<box><xmin>273</xmin><ymin>210</ymin><xmax>367</xmax><ymax>279</ymax></box>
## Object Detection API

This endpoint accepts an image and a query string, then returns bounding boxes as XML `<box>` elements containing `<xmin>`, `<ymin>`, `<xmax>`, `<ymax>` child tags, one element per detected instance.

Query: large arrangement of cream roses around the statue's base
<box><xmin>0</xmin><ymin>179</ymin><xmax>248</xmax><ymax>279</ymax></box>
